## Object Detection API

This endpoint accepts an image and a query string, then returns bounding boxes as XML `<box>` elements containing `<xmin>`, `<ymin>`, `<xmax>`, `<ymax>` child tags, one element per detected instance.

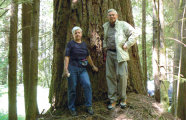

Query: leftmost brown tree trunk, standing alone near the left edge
<box><xmin>8</xmin><ymin>0</ymin><xmax>18</xmax><ymax>120</ymax></box>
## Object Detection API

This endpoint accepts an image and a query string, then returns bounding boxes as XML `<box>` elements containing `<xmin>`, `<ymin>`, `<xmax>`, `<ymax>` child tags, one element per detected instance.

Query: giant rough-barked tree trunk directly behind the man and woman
<box><xmin>50</xmin><ymin>0</ymin><xmax>146</xmax><ymax>109</ymax></box>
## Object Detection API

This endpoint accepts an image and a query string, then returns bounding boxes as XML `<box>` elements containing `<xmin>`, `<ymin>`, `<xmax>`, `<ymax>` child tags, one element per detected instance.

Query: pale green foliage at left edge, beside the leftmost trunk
<box><xmin>0</xmin><ymin>0</ymin><xmax>10</xmax><ymax>85</ymax></box>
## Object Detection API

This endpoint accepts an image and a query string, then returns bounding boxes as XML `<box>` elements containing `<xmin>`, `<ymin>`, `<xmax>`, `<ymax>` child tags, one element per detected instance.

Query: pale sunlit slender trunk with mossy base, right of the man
<box><xmin>159</xmin><ymin>0</ymin><xmax>169</xmax><ymax>110</ymax></box>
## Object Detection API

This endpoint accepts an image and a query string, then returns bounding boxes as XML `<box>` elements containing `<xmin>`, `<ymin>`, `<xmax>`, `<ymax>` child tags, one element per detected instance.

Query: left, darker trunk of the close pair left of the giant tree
<box><xmin>22</xmin><ymin>3</ymin><xmax>32</xmax><ymax>113</ymax></box>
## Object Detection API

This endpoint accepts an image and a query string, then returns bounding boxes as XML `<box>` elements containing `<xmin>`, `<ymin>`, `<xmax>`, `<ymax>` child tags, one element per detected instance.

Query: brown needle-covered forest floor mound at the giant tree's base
<box><xmin>39</xmin><ymin>93</ymin><xmax>174</xmax><ymax>120</ymax></box>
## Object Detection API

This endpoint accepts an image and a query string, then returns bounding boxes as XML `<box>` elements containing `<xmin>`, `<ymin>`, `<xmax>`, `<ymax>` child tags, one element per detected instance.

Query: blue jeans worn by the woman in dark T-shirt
<box><xmin>68</xmin><ymin>65</ymin><xmax>92</xmax><ymax>110</ymax></box>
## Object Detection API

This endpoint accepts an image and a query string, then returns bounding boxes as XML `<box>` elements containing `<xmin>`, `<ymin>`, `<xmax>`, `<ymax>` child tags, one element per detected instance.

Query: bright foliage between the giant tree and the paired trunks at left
<box><xmin>38</xmin><ymin>0</ymin><xmax>53</xmax><ymax>87</ymax></box>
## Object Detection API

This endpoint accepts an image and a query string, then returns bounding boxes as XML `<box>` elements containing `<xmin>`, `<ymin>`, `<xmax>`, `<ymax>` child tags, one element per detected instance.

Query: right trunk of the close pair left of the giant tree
<box><xmin>26</xmin><ymin>0</ymin><xmax>40</xmax><ymax>120</ymax></box>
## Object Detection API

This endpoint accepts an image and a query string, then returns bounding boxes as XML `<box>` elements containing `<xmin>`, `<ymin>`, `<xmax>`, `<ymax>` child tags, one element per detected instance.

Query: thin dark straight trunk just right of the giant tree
<box><xmin>142</xmin><ymin>0</ymin><xmax>147</xmax><ymax>89</ymax></box>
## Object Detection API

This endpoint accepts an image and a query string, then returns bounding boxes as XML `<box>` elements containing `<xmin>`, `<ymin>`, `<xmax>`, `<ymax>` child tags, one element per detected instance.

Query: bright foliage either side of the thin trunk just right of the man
<box><xmin>132</xmin><ymin>0</ymin><xmax>153</xmax><ymax>80</ymax></box>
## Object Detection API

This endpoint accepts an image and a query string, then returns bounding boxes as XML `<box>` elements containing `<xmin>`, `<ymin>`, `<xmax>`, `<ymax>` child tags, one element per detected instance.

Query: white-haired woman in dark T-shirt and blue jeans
<box><xmin>64</xmin><ymin>26</ymin><xmax>98</xmax><ymax>116</ymax></box>
